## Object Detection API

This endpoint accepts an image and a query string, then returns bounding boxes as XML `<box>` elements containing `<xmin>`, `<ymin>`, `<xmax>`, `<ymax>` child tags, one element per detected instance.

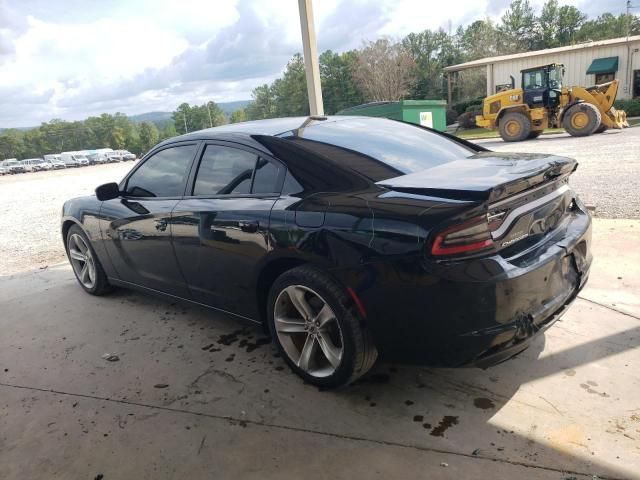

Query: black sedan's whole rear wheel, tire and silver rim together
<box><xmin>267</xmin><ymin>266</ymin><xmax>378</xmax><ymax>388</ymax></box>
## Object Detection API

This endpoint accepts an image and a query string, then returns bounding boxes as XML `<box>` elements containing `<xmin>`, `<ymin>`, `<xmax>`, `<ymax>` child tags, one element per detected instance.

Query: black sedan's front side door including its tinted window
<box><xmin>101</xmin><ymin>142</ymin><xmax>199</xmax><ymax>298</ymax></box>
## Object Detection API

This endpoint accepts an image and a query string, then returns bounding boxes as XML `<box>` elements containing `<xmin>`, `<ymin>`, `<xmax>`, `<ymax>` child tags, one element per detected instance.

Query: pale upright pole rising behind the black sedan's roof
<box><xmin>298</xmin><ymin>0</ymin><xmax>324</xmax><ymax>116</ymax></box>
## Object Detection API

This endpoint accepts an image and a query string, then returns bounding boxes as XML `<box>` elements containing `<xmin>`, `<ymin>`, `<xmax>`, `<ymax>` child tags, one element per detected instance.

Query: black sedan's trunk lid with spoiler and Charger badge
<box><xmin>377</xmin><ymin>152</ymin><xmax>578</xmax><ymax>258</ymax></box>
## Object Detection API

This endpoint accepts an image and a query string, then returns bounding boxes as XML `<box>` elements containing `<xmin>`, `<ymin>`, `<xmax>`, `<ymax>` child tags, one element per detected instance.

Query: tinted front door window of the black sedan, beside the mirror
<box><xmin>126</xmin><ymin>144</ymin><xmax>198</xmax><ymax>197</ymax></box>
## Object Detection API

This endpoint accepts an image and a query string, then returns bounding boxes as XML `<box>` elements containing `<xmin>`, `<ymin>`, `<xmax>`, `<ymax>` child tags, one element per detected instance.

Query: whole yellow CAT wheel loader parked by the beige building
<box><xmin>476</xmin><ymin>63</ymin><xmax>629</xmax><ymax>142</ymax></box>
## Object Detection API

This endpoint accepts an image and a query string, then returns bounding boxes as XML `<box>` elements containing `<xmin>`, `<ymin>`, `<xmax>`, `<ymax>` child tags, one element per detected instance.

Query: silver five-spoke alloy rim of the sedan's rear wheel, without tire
<box><xmin>274</xmin><ymin>285</ymin><xmax>344</xmax><ymax>377</ymax></box>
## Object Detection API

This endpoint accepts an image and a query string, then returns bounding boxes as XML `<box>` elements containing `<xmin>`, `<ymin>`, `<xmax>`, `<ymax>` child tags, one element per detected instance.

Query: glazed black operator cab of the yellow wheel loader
<box><xmin>521</xmin><ymin>63</ymin><xmax>564</xmax><ymax>108</ymax></box>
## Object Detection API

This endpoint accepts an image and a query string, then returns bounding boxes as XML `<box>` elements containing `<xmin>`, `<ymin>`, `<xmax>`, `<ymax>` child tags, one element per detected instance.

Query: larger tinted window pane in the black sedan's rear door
<box><xmin>193</xmin><ymin>145</ymin><xmax>258</xmax><ymax>195</ymax></box>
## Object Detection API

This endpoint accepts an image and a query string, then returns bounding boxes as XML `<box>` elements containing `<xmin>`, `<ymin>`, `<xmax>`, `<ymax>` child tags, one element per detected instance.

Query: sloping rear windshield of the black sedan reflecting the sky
<box><xmin>281</xmin><ymin>117</ymin><xmax>476</xmax><ymax>174</ymax></box>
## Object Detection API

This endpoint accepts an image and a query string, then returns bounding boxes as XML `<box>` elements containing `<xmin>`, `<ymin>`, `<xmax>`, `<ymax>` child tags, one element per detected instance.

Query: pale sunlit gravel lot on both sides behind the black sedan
<box><xmin>0</xmin><ymin>128</ymin><xmax>640</xmax><ymax>275</ymax></box>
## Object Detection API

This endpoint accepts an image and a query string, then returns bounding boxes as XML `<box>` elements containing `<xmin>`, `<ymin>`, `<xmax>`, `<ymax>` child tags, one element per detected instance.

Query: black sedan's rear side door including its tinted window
<box><xmin>171</xmin><ymin>142</ymin><xmax>285</xmax><ymax>318</ymax></box>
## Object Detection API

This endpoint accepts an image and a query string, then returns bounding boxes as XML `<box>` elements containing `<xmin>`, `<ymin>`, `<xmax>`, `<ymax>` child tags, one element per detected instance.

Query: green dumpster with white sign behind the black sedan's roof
<box><xmin>336</xmin><ymin>100</ymin><xmax>447</xmax><ymax>132</ymax></box>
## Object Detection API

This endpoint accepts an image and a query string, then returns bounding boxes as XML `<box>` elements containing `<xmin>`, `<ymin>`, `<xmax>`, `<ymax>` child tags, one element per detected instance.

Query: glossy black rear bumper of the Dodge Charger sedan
<box><xmin>338</xmin><ymin>207</ymin><xmax>591</xmax><ymax>368</ymax></box>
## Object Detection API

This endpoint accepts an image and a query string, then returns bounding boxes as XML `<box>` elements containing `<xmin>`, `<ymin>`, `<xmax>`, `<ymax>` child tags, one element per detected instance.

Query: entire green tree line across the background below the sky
<box><xmin>0</xmin><ymin>0</ymin><xmax>640</xmax><ymax>159</ymax></box>
